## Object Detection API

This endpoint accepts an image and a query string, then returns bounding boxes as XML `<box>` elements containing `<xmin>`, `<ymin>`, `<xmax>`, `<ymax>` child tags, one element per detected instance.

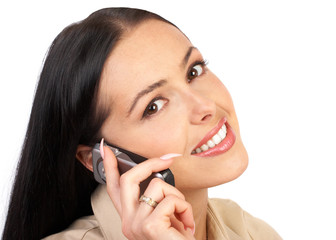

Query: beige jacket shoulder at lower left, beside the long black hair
<box><xmin>43</xmin><ymin>216</ymin><xmax>104</xmax><ymax>240</ymax></box>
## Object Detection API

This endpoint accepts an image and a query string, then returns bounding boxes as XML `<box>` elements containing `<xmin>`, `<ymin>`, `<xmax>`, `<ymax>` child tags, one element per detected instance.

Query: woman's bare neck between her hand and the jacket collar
<box><xmin>183</xmin><ymin>188</ymin><xmax>208</xmax><ymax>240</ymax></box>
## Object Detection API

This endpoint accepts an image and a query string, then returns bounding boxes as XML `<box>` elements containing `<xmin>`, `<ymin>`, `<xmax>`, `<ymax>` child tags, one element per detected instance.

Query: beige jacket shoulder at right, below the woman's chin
<box><xmin>208</xmin><ymin>198</ymin><xmax>282</xmax><ymax>240</ymax></box>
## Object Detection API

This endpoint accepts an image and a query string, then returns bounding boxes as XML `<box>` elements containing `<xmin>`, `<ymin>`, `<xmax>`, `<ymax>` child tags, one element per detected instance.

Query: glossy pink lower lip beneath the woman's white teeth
<box><xmin>192</xmin><ymin>122</ymin><xmax>236</xmax><ymax>157</ymax></box>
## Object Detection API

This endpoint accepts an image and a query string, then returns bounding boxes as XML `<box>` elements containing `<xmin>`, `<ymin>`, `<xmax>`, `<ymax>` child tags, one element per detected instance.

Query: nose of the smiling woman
<box><xmin>187</xmin><ymin>91</ymin><xmax>216</xmax><ymax>124</ymax></box>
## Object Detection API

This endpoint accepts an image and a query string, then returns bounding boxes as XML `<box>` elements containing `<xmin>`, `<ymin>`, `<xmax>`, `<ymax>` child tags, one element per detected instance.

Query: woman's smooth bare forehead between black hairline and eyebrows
<box><xmin>100</xmin><ymin>20</ymin><xmax>191</xmax><ymax>113</ymax></box>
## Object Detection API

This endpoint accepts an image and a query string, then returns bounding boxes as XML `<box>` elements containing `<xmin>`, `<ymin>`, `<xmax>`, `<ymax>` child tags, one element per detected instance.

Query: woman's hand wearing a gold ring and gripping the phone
<box><xmin>102</xmin><ymin>142</ymin><xmax>195</xmax><ymax>240</ymax></box>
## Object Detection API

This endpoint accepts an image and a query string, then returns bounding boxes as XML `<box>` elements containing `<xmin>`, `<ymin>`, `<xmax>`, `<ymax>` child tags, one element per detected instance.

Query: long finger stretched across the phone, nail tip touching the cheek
<box><xmin>120</xmin><ymin>158</ymin><xmax>173</xmax><ymax>218</ymax></box>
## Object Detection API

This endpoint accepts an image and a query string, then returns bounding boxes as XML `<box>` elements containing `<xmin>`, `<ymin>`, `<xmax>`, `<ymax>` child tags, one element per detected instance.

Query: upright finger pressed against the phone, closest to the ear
<box><xmin>103</xmin><ymin>142</ymin><xmax>121</xmax><ymax>215</ymax></box>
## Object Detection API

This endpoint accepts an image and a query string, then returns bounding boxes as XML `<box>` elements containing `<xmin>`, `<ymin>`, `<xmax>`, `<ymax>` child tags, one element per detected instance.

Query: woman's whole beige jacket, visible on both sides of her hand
<box><xmin>44</xmin><ymin>185</ymin><xmax>282</xmax><ymax>240</ymax></box>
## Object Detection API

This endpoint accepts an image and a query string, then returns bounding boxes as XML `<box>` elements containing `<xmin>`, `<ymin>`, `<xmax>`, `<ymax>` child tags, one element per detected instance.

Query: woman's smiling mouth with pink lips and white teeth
<box><xmin>191</xmin><ymin>117</ymin><xmax>236</xmax><ymax>157</ymax></box>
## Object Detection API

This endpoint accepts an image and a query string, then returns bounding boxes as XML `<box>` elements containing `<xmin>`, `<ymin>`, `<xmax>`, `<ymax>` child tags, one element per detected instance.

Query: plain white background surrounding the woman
<box><xmin>0</xmin><ymin>0</ymin><xmax>336</xmax><ymax>239</ymax></box>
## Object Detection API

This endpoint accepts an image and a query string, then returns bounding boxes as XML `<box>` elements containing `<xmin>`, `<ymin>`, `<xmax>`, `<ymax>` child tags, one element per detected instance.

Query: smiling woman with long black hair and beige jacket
<box><xmin>3</xmin><ymin>8</ymin><xmax>280</xmax><ymax>239</ymax></box>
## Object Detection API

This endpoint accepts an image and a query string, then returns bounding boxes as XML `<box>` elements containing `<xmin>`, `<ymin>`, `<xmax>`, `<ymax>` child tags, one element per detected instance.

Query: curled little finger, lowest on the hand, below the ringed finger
<box><xmin>151</xmin><ymin>195</ymin><xmax>195</xmax><ymax>232</ymax></box>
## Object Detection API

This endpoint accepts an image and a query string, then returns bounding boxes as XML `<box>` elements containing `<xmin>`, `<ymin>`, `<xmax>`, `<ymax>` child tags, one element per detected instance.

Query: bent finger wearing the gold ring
<box><xmin>137</xmin><ymin>178</ymin><xmax>185</xmax><ymax>217</ymax></box>
